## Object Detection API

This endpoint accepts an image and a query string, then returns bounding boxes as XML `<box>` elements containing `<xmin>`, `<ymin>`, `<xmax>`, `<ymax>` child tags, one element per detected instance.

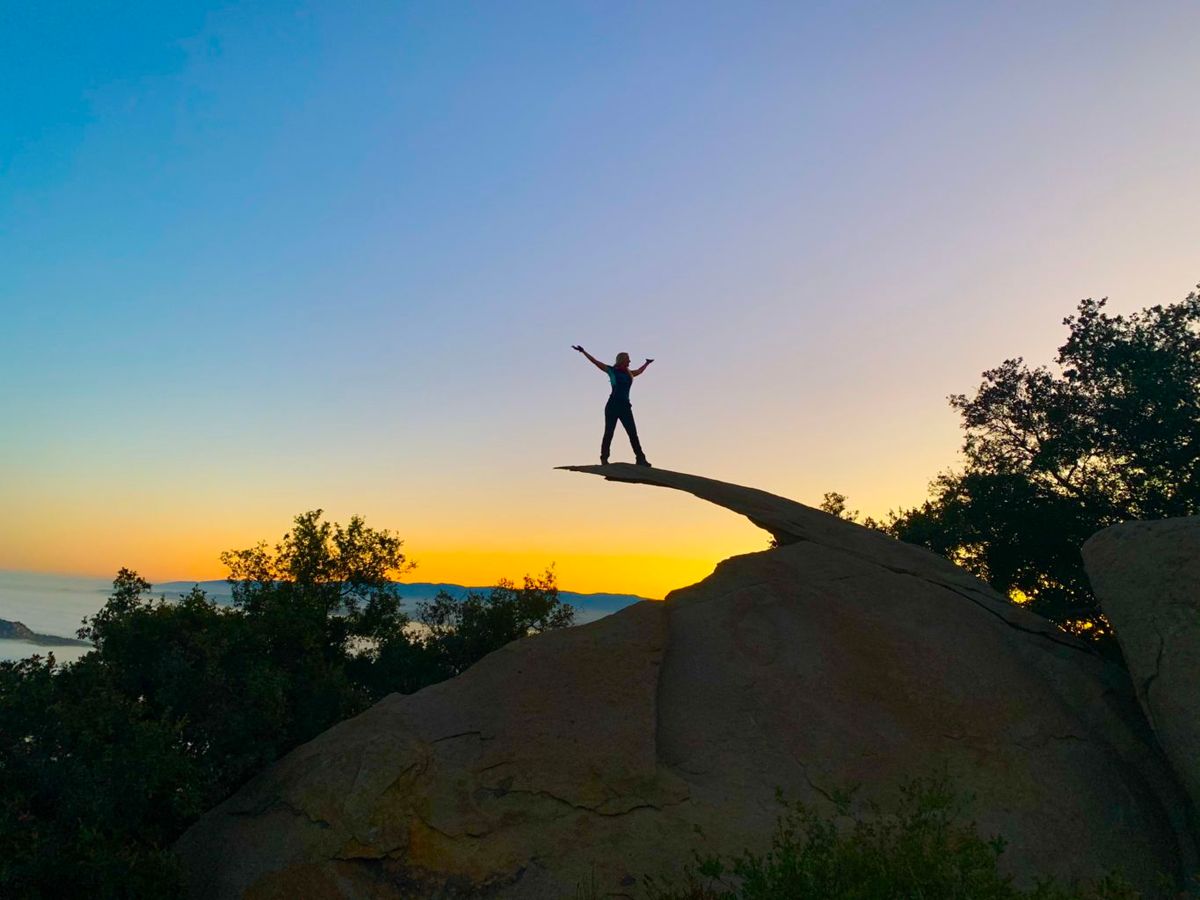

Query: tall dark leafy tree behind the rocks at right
<box><xmin>892</xmin><ymin>293</ymin><xmax>1200</xmax><ymax>652</ymax></box>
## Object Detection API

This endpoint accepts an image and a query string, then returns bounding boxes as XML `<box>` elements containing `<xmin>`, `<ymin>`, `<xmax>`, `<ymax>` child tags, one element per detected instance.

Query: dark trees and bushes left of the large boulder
<box><xmin>0</xmin><ymin>510</ymin><xmax>572</xmax><ymax>898</ymax></box>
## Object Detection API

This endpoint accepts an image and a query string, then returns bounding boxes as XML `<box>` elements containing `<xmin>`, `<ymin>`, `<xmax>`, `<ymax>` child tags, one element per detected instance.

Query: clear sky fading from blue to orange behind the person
<box><xmin>0</xmin><ymin>0</ymin><xmax>1200</xmax><ymax>596</ymax></box>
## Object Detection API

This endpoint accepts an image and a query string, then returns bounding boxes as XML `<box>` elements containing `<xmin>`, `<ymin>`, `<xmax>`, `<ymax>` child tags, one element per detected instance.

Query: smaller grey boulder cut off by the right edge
<box><xmin>1084</xmin><ymin>516</ymin><xmax>1200</xmax><ymax>825</ymax></box>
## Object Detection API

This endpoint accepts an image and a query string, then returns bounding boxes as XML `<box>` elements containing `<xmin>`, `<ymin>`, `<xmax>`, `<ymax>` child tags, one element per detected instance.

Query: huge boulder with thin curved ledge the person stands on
<box><xmin>176</xmin><ymin>464</ymin><xmax>1194</xmax><ymax>900</ymax></box>
